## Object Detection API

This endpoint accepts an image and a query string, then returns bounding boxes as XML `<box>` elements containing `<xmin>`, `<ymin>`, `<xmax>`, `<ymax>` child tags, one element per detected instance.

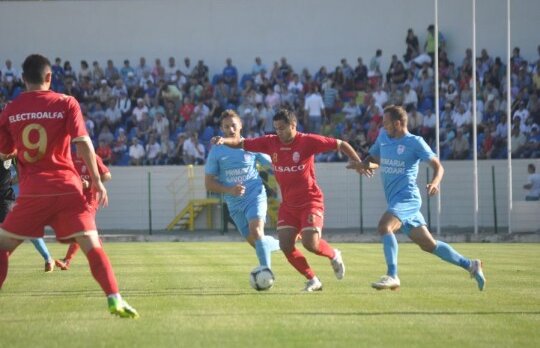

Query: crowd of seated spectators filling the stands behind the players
<box><xmin>0</xmin><ymin>25</ymin><xmax>540</xmax><ymax>165</ymax></box>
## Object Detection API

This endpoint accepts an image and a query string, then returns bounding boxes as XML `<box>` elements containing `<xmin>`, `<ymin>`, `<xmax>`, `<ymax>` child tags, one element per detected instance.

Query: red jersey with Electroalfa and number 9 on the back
<box><xmin>0</xmin><ymin>91</ymin><xmax>88</xmax><ymax>196</ymax></box>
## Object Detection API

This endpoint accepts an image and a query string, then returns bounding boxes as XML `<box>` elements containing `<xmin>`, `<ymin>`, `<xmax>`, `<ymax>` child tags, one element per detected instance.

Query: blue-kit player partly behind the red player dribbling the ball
<box><xmin>205</xmin><ymin>110</ymin><xmax>279</xmax><ymax>268</ymax></box>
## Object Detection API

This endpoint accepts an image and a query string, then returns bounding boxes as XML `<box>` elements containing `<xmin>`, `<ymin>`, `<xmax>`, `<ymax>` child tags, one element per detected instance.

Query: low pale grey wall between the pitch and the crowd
<box><xmin>98</xmin><ymin>160</ymin><xmax>540</xmax><ymax>231</ymax></box>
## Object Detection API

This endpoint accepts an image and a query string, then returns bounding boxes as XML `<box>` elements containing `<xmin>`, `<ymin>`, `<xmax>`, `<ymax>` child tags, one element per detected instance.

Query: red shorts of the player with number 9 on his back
<box><xmin>2</xmin><ymin>193</ymin><xmax>97</xmax><ymax>240</ymax></box>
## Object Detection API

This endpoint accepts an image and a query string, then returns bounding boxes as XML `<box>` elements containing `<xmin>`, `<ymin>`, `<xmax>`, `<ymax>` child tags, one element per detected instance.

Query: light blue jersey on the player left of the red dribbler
<box><xmin>205</xmin><ymin>145</ymin><xmax>270</xmax><ymax>211</ymax></box>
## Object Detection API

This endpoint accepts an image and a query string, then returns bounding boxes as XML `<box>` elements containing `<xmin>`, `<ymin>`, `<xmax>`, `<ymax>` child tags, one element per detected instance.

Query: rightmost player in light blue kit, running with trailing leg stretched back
<box><xmin>348</xmin><ymin>105</ymin><xmax>486</xmax><ymax>290</ymax></box>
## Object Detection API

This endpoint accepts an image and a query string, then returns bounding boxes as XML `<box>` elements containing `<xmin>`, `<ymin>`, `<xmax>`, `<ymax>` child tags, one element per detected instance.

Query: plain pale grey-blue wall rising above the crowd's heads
<box><xmin>0</xmin><ymin>0</ymin><xmax>540</xmax><ymax>73</ymax></box>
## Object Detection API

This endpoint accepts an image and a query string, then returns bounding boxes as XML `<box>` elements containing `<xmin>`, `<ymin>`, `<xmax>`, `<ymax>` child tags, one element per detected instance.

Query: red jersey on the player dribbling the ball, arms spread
<box><xmin>244</xmin><ymin>132</ymin><xmax>337</xmax><ymax>207</ymax></box>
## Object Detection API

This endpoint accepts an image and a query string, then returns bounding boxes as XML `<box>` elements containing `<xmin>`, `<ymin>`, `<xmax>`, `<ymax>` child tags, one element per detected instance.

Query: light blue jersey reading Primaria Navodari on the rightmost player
<box><xmin>369</xmin><ymin>129</ymin><xmax>435</xmax><ymax>207</ymax></box>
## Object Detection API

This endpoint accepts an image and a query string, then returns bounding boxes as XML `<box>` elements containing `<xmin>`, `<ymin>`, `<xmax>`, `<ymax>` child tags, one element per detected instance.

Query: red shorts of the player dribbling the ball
<box><xmin>277</xmin><ymin>204</ymin><xmax>324</xmax><ymax>232</ymax></box>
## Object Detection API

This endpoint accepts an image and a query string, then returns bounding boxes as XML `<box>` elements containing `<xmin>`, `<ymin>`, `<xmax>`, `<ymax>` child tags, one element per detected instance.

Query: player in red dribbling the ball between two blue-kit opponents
<box><xmin>212</xmin><ymin>109</ymin><xmax>359</xmax><ymax>292</ymax></box>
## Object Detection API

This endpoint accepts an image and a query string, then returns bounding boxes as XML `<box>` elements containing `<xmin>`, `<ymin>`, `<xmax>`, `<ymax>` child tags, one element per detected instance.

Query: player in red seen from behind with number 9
<box><xmin>0</xmin><ymin>54</ymin><xmax>139</xmax><ymax>318</ymax></box>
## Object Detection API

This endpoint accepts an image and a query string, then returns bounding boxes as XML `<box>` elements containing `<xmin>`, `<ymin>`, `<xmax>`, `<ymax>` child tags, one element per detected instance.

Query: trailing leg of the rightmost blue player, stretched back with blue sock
<box><xmin>409</xmin><ymin>225</ymin><xmax>486</xmax><ymax>291</ymax></box>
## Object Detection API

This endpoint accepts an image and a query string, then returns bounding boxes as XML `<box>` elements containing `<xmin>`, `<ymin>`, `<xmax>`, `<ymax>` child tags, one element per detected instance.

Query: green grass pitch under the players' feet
<box><xmin>0</xmin><ymin>243</ymin><xmax>540</xmax><ymax>348</ymax></box>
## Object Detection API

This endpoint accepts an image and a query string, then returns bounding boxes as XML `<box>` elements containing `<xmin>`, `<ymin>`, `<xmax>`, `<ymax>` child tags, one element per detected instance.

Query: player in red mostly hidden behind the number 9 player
<box><xmin>55</xmin><ymin>153</ymin><xmax>112</xmax><ymax>271</ymax></box>
